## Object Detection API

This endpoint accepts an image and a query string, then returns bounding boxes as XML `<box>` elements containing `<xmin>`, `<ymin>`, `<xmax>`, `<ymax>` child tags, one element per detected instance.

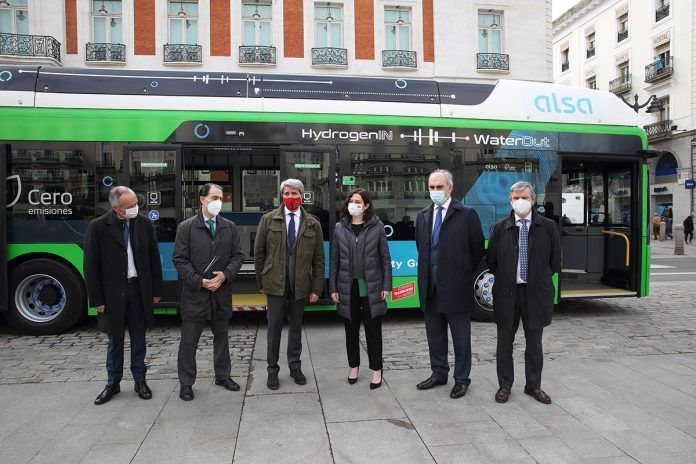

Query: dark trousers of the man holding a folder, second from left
<box><xmin>177</xmin><ymin>318</ymin><xmax>232</xmax><ymax>385</ymax></box>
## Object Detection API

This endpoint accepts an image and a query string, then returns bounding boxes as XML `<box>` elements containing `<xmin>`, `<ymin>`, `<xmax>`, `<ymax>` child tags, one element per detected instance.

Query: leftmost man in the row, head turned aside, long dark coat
<box><xmin>84</xmin><ymin>186</ymin><xmax>162</xmax><ymax>405</ymax></box>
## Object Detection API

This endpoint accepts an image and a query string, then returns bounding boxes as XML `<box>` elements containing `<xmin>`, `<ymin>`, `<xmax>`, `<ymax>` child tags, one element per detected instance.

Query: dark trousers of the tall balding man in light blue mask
<box><xmin>425</xmin><ymin>292</ymin><xmax>471</xmax><ymax>385</ymax></box>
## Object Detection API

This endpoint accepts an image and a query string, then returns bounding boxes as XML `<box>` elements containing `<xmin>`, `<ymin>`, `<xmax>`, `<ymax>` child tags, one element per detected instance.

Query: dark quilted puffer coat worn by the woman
<box><xmin>329</xmin><ymin>216</ymin><xmax>392</xmax><ymax>319</ymax></box>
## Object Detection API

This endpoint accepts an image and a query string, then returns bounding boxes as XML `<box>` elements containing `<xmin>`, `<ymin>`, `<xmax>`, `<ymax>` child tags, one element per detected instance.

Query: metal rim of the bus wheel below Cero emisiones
<box><xmin>15</xmin><ymin>274</ymin><xmax>65</xmax><ymax>324</ymax></box>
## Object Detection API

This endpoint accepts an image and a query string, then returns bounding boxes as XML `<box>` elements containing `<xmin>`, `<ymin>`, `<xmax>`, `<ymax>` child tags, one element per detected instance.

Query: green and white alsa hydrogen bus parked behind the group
<box><xmin>0</xmin><ymin>65</ymin><xmax>650</xmax><ymax>334</ymax></box>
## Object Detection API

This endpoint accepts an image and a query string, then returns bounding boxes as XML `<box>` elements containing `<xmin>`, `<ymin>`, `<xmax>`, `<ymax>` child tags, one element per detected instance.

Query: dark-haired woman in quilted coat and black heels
<box><xmin>329</xmin><ymin>188</ymin><xmax>392</xmax><ymax>389</ymax></box>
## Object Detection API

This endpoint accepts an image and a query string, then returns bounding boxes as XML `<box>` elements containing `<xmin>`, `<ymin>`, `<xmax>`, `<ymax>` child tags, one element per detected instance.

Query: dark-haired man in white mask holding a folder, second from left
<box><xmin>173</xmin><ymin>183</ymin><xmax>244</xmax><ymax>401</ymax></box>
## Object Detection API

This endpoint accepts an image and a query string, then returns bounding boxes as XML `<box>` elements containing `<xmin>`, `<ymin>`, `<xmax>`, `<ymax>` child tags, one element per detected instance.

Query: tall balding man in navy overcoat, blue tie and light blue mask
<box><xmin>416</xmin><ymin>169</ymin><xmax>485</xmax><ymax>398</ymax></box>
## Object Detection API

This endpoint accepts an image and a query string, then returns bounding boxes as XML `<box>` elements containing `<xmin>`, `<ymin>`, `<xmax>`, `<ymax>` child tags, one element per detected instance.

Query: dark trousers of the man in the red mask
<box><xmin>266</xmin><ymin>290</ymin><xmax>306</xmax><ymax>374</ymax></box>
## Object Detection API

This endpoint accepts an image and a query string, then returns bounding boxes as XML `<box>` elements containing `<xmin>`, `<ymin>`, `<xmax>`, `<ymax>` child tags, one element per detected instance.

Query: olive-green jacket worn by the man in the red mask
<box><xmin>254</xmin><ymin>204</ymin><xmax>326</xmax><ymax>300</ymax></box>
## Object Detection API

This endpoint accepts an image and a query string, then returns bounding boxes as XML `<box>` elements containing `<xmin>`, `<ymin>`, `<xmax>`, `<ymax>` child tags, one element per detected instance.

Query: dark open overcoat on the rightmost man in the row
<box><xmin>487</xmin><ymin>212</ymin><xmax>561</xmax><ymax>330</ymax></box>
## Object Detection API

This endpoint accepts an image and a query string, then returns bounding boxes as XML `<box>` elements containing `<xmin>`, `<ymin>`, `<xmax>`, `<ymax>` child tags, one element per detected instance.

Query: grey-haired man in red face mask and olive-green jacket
<box><xmin>254</xmin><ymin>179</ymin><xmax>324</xmax><ymax>390</ymax></box>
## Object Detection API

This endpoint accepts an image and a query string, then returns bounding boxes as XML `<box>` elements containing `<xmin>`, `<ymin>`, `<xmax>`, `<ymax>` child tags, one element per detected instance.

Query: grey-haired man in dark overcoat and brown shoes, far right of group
<box><xmin>487</xmin><ymin>181</ymin><xmax>561</xmax><ymax>404</ymax></box>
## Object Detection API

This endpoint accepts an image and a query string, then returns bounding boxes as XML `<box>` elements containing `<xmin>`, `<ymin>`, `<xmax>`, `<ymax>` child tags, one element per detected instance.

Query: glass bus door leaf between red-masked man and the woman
<box><xmin>280</xmin><ymin>146</ymin><xmax>340</xmax><ymax>304</ymax></box>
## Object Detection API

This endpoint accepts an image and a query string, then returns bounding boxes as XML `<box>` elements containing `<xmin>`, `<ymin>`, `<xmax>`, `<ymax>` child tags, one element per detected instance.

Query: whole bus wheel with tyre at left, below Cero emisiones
<box><xmin>5</xmin><ymin>258</ymin><xmax>87</xmax><ymax>335</ymax></box>
